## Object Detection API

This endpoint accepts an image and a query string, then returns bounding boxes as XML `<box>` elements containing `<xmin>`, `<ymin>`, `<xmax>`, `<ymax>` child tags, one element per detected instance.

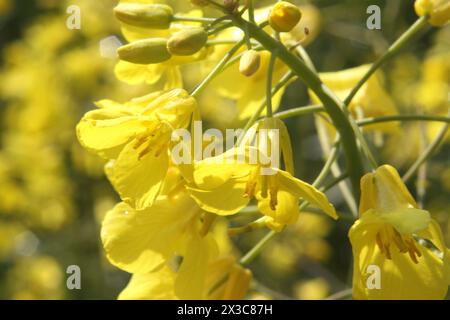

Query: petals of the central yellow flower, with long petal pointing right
<box><xmin>188</xmin><ymin>147</ymin><xmax>337</xmax><ymax>225</ymax></box>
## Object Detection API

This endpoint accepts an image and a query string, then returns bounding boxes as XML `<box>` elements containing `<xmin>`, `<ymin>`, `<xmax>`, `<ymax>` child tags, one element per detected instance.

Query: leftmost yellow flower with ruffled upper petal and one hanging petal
<box><xmin>77</xmin><ymin>89</ymin><xmax>196</xmax><ymax>209</ymax></box>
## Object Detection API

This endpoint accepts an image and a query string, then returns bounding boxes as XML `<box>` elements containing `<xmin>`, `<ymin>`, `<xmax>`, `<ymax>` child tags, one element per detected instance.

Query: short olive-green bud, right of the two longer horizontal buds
<box><xmin>167</xmin><ymin>28</ymin><xmax>208</xmax><ymax>56</ymax></box>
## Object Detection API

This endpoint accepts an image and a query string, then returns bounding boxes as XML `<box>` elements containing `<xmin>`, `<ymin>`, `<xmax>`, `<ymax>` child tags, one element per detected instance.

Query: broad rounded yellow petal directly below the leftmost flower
<box><xmin>101</xmin><ymin>192</ymin><xmax>200</xmax><ymax>273</ymax></box>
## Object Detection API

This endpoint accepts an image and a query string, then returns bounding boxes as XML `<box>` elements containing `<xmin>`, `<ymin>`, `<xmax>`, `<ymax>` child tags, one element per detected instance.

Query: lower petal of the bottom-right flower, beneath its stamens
<box><xmin>349</xmin><ymin>216</ymin><xmax>448</xmax><ymax>300</ymax></box>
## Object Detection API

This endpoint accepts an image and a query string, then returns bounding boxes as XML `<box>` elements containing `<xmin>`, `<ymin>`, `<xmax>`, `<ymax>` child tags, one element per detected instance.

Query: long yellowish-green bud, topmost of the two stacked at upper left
<box><xmin>114</xmin><ymin>3</ymin><xmax>173</xmax><ymax>29</ymax></box>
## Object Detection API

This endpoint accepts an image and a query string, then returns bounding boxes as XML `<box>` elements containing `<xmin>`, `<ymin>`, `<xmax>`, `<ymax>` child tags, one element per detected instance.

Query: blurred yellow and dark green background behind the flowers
<box><xmin>0</xmin><ymin>0</ymin><xmax>450</xmax><ymax>299</ymax></box>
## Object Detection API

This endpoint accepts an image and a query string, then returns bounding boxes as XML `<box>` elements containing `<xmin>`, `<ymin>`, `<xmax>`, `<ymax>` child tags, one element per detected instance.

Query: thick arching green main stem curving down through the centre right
<box><xmin>232</xmin><ymin>16</ymin><xmax>364</xmax><ymax>199</ymax></box>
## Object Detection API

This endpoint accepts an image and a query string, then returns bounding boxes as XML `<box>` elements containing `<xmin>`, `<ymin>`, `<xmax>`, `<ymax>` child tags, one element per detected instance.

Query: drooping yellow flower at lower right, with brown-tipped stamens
<box><xmin>349</xmin><ymin>165</ymin><xmax>450</xmax><ymax>300</ymax></box>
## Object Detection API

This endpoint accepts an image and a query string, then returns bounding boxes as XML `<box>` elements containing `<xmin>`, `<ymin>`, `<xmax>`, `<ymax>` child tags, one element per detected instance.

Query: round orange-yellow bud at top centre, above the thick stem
<box><xmin>269</xmin><ymin>1</ymin><xmax>302</xmax><ymax>32</ymax></box>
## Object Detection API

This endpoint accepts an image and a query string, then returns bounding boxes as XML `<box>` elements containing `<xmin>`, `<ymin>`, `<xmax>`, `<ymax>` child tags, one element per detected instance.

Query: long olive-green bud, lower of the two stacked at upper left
<box><xmin>117</xmin><ymin>38</ymin><xmax>171</xmax><ymax>64</ymax></box>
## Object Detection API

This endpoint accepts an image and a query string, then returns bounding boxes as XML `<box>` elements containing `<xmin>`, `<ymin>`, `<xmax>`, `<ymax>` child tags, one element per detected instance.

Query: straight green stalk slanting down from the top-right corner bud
<box><xmin>344</xmin><ymin>16</ymin><xmax>427</xmax><ymax>107</ymax></box>
